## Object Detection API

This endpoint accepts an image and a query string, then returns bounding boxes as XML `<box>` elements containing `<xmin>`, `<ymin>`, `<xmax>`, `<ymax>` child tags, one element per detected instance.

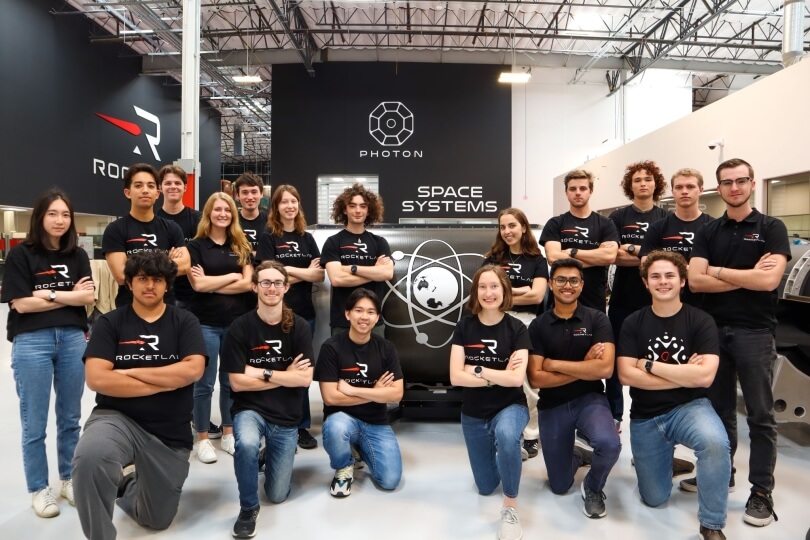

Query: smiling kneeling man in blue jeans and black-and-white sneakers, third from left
<box><xmin>315</xmin><ymin>288</ymin><xmax>405</xmax><ymax>497</ymax></box>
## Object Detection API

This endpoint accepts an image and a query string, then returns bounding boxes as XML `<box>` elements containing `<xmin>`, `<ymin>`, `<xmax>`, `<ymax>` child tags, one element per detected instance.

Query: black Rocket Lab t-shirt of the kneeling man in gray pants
<box><xmin>84</xmin><ymin>305</ymin><xmax>208</xmax><ymax>449</ymax></box>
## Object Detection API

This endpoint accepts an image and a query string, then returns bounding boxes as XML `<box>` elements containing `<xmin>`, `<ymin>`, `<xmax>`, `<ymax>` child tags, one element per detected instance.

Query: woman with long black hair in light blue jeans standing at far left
<box><xmin>0</xmin><ymin>188</ymin><xmax>95</xmax><ymax>517</ymax></box>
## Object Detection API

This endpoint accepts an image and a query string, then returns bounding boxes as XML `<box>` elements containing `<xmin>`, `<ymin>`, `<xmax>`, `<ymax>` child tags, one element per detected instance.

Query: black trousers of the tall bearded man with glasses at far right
<box><xmin>709</xmin><ymin>326</ymin><xmax>776</xmax><ymax>494</ymax></box>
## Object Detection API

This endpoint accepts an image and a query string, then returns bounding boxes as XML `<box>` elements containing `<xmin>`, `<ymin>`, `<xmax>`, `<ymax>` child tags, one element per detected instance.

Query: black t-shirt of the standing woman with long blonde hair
<box><xmin>188</xmin><ymin>238</ymin><xmax>256</xmax><ymax>326</ymax></box>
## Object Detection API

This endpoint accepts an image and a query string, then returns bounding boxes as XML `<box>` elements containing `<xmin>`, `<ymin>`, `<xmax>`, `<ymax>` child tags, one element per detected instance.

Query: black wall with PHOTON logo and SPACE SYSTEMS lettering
<box><xmin>272</xmin><ymin>63</ymin><xmax>512</xmax><ymax>223</ymax></box>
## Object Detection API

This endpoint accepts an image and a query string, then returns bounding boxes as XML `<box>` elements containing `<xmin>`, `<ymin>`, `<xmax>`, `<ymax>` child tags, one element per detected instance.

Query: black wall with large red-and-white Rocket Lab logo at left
<box><xmin>0</xmin><ymin>0</ymin><xmax>221</xmax><ymax>215</ymax></box>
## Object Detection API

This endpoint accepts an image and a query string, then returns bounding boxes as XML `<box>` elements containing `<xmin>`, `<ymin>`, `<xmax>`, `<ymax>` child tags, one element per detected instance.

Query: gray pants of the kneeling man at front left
<box><xmin>73</xmin><ymin>410</ymin><xmax>190</xmax><ymax>540</ymax></box>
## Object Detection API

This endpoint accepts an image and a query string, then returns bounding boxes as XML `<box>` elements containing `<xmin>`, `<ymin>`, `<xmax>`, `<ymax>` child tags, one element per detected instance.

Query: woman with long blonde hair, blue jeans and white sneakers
<box><xmin>188</xmin><ymin>192</ymin><xmax>256</xmax><ymax>463</ymax></box>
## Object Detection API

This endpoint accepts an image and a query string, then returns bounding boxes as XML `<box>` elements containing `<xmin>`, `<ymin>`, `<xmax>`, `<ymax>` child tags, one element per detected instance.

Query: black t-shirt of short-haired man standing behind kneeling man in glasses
<box><xmin>539</xmin><ymin>212</ymin><xmax>619</xmax><ymax>311</ymax></box>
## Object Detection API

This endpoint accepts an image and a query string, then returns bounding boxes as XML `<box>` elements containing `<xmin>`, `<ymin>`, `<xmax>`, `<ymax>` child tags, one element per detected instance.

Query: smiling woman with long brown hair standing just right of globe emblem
<box><xmin>484</xmin><ymin>208</ymin><xmax>548</xmax><ymax>460</ymax></box>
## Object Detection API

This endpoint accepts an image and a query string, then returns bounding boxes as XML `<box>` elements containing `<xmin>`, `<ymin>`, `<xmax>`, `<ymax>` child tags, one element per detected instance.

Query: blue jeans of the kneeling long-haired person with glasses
<box><xmin>233</xmin><ymin>411</ymin><xmax>298</xmax><ymax>510</ymax></box>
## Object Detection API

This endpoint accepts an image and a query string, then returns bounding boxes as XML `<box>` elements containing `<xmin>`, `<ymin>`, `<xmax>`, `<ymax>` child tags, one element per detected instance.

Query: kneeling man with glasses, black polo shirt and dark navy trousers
<box><xmin>527</xmin><ymin>259</ymin><xmax>622</xmax><ymax>518</ymax></box>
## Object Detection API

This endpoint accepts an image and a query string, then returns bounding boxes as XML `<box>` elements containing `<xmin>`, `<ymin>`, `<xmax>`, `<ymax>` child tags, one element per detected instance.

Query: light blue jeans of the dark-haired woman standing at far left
<box><xmin>11</xmin><ymin>326</ymin><xmax>87</xmax><ymax>493</ymax></box>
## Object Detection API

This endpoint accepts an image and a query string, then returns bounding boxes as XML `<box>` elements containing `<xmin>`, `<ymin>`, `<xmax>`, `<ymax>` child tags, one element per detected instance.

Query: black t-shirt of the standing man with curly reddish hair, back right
<box><xmin>610</xmin><ymin>204</ymin><xmax>668</xmax><ymax>309</ymax></box>
